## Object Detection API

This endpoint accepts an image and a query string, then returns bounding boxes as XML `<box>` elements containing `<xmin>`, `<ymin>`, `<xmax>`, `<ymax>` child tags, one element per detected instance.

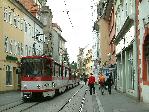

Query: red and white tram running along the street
<box><xmin>17</xmin><ymin>56</ymin><xmax>80</xmax><ymax>100</ymax></box>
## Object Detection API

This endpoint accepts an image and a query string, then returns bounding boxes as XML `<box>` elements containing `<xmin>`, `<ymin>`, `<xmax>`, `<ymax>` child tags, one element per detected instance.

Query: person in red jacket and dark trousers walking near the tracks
<box><xmin>88</xmin><ymin>73</ymin><xmax>95</xmax><ymax>95</ymax></box>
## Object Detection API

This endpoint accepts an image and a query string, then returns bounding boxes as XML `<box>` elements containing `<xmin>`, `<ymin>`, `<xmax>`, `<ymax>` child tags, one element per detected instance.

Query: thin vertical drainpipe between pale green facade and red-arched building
<box><xmin>134</xmin><ymin>0</ymin><xmax>141</xmax><ymax>101</ymax></box>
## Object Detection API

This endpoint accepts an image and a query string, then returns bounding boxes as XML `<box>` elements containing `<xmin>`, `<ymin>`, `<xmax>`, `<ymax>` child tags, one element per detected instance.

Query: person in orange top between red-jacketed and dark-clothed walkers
<box><xmin>98</xmin><ymin>73</ymin><xmax>105</xmax><ymax>95</ymax></box>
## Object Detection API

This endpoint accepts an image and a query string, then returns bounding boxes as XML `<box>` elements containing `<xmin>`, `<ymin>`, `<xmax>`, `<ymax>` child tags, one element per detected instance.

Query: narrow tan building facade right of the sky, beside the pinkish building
<box><xmin>96</xmin><ymin>0</ymin><xmax>110</xmax><ymax>68</ymax></box>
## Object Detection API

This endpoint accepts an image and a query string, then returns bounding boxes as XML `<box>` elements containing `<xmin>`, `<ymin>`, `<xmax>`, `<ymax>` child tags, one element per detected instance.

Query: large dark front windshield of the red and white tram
<box><xmin>21</xmin><ymin>58</ymin><xmax>44</xmax><ymax>76</ymax></box>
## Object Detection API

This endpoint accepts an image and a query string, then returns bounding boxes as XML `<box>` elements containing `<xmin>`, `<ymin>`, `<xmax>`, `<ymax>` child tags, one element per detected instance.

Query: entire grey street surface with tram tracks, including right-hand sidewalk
<box><xmin>0</xmin><ymin>82</ymin><xmax>149</xmax><ymax>112</ymax></box>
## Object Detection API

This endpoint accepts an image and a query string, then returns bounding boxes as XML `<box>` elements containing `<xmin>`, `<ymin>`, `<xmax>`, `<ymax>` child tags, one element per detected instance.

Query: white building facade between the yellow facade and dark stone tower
<box><xmin>24</xmin><ymin>15</ymin><xmax>45</xmax><ymax>56</ymax></box>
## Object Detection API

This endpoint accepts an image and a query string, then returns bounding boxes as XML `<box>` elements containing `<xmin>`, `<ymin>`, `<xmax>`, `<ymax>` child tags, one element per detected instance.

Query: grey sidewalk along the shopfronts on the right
<box><xmin>96</xmin><ymin>86</ymin><xmax>149</xmax><ymax>112</ymax></box>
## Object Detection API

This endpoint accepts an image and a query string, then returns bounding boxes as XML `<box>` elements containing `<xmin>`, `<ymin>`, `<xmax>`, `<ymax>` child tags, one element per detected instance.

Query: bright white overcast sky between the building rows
<box><xmin>47</xmin><ymin>0</ymin><xmax>96</xmax><ymax>62</ymax></box>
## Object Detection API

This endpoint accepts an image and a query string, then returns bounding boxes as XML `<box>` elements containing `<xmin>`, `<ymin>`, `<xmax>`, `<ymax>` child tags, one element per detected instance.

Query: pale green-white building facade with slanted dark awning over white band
<box><xmin>115</xmin><ymin>0</ymin><xmax>138</xmax><ymax>97</ymax></box>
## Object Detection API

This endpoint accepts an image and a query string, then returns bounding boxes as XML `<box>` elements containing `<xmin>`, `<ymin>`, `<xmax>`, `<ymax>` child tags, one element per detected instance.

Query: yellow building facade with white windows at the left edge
<box><xmin>0</xmin><ymin>0</ymin><xmax>24</xmax><ymax>91</ymax></box>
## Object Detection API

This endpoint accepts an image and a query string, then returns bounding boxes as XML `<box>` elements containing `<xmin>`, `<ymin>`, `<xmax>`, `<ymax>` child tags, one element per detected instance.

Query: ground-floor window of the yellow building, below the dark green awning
<box><xmin>6</xmin><ymin>65</ymin><xmax>12</xmax><ymax>85</ymax></box>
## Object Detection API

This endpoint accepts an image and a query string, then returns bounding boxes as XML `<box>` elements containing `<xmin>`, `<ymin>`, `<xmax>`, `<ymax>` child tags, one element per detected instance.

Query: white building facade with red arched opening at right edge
<box><xmin>136</xmin><ymin>0</ymin><xmax>149</xmax><ymax>103</ymax></box>
